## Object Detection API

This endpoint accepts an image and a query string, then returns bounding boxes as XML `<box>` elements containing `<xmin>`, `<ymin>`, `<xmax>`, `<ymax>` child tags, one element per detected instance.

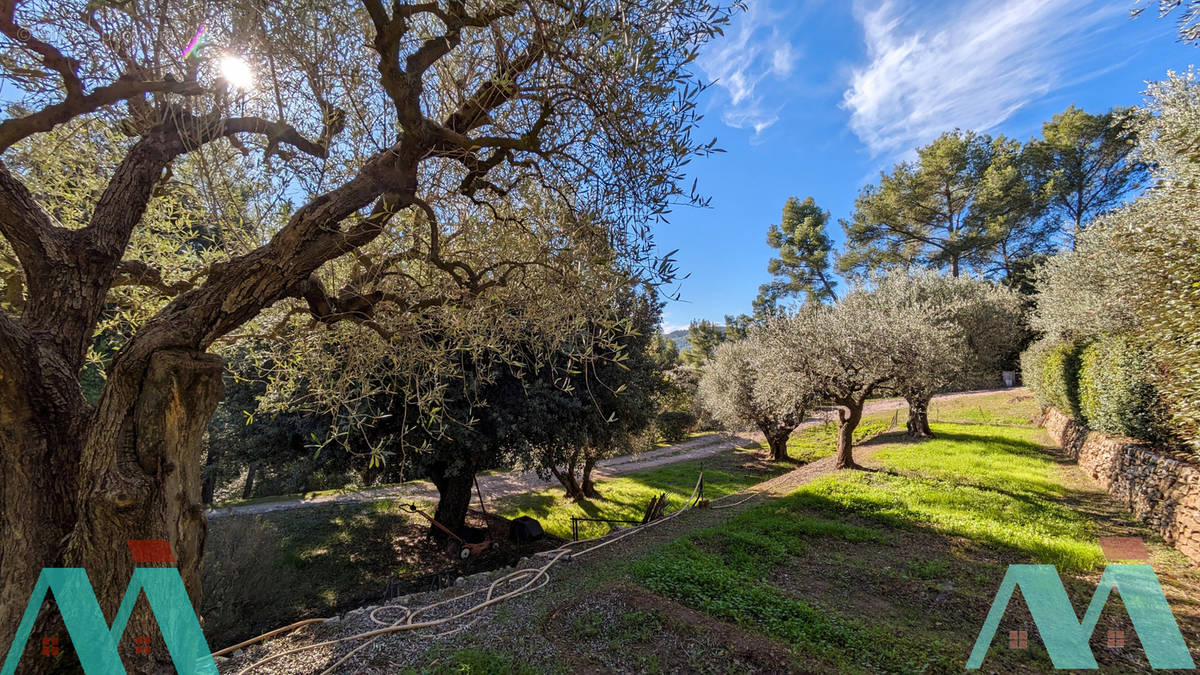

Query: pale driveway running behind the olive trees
<box><xmin>208</xmin><ymin>389</ymin><xmax>1003</xmax><ymax>519</ymax></box>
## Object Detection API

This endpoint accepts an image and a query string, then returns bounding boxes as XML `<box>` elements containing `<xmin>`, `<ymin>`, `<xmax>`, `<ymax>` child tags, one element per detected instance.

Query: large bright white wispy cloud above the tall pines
<box><xmin>842</xmin><ymin>0</ymin><xmax>1128</xmax><ymax>155</ymax></box>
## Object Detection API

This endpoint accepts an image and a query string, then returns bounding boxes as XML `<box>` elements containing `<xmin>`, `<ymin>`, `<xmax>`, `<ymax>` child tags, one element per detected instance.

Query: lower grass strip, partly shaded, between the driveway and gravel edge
<box><xmin>202</xmin><ymin>423</ymin><xmax>854</xmax><ymax>649</ymax></box>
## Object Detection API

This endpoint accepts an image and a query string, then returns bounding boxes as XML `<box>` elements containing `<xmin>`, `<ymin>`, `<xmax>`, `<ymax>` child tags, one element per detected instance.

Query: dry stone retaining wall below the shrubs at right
<box><xmin>1044</xmin><ymin>408</ymin><xmax>1200</xmax><ymax>563</ymax></box>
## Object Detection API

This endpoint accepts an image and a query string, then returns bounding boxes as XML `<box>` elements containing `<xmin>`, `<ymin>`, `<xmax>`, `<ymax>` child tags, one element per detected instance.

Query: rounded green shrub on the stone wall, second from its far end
<box><xmin>1079</xmin><ymin>335</ymin><xmax>1163</xmax><ymax>442</ymax></box>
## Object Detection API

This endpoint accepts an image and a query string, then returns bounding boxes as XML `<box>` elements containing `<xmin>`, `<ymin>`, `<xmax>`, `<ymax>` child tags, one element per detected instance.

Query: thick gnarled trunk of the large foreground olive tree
<box><xmin>0</xmin><ymin>350</ymin><xmax>222</xmax><ymax>673</ymax></box>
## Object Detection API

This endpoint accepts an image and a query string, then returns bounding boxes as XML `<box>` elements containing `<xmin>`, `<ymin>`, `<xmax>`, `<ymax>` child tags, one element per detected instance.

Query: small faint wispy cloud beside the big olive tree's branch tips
<box><xmin>698</xmin><ymin>0</ymin><xmax>799</xmax><ymax>136</ymax></box>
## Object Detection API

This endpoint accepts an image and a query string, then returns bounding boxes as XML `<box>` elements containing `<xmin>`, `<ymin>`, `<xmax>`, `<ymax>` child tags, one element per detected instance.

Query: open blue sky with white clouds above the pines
<box><xmin>655</xmin><ymin>0</ymin><xmax>1196</xmax><ymax>330</ymax></box>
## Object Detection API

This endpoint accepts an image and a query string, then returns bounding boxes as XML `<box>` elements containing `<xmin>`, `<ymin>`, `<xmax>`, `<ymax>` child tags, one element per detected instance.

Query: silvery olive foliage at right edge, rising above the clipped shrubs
<box><xmin>1027</xmin><ymin>70</ymin><xmax>1200</xmax><ymax>448</ymax></box>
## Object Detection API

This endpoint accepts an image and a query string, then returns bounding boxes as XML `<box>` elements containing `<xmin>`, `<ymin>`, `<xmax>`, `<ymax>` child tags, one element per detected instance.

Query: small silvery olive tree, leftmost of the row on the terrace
<box><xmin>700</xmin><ymin>335</ymin><xmax>812</xmax><ymax>461</ymax></box>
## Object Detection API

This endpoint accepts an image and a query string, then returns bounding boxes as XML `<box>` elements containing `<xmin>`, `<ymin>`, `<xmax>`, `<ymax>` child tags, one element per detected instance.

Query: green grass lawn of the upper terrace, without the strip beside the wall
<box><xmin>632</xmin><ymin>395</ymin><xmax>1128</xmax><ymax>671</ymax></box>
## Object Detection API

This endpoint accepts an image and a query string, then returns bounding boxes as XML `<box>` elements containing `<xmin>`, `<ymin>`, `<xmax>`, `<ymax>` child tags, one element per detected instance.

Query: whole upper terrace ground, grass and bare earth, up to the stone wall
<box><xmin>223</xmin><ymin>394</ymin><xmax>1200</xmax><ymax>673</ymax></box>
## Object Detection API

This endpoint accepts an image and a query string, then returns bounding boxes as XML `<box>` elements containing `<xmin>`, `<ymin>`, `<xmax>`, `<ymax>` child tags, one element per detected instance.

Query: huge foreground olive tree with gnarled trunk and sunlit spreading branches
<box><xmin>0</xmin><ymin>0</ymin><xmax>730</xmax><ymax>667</ymax></box>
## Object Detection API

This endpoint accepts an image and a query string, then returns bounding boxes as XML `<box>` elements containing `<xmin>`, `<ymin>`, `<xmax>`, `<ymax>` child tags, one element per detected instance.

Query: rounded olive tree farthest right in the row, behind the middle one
<box><xmin>871</xmin><ymin>270</ymin><xmax>1025</xmax><ymax>438</ymax></box>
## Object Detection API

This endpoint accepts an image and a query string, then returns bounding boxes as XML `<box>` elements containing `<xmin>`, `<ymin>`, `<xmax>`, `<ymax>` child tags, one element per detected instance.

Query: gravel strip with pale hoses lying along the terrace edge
<box><xmin>218</xmin><ymin>446</ymin><xmax>897</xmax><ymax>675</ymax></box>
